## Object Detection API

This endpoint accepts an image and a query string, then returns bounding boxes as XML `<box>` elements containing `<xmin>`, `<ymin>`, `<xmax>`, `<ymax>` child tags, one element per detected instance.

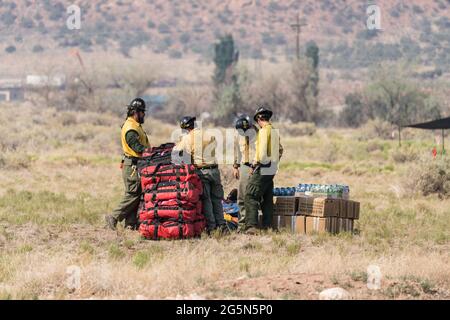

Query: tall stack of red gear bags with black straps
<box><xmin>138</xmin><ymin>143</ymin><xmax>206</xmax><ymax>240</ymax></box>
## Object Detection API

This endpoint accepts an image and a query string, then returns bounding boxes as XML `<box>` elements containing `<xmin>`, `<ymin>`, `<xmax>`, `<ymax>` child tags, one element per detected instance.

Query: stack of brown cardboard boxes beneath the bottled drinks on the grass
<box><xmin>272</xmin><ymin>196</ymin><xmax>360</xmax><ymax>234</ymax></box>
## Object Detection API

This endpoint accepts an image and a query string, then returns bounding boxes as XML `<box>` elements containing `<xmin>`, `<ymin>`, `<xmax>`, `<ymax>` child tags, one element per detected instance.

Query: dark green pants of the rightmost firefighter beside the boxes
<box><xmin>244</xmin><ymin>169</ymin><xmax>274</xmax><ymax>228</ymax></box>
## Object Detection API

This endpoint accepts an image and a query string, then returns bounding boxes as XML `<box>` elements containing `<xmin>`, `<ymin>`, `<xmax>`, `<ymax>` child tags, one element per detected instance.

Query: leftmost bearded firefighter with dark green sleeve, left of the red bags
<box><xmin>106</xmin><ymin>98</ymin><xmax>150</xmax><ymax>230</ymax></box>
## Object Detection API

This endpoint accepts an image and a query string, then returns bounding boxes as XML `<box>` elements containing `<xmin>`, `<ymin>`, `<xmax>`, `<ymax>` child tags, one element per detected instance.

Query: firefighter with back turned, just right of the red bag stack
<box><xmin>174</xmin><ymin>116</ymin><xmax>228</xmax><ymax>233</ymax></box>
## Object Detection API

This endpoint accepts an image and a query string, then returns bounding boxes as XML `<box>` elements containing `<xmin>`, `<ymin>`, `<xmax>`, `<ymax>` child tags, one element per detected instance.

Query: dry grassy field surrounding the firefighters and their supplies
<box><xmin>0</xmin><ymin>106</ymin><xmax>450</xmax><ymax>299</ymax></box>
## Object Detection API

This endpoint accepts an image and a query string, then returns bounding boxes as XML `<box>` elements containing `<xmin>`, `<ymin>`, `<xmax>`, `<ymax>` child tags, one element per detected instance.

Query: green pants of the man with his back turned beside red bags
<box><xmin>197</xmin><ymin>168</ymin><xmax>226</xmax><ymax>231</ymax></box>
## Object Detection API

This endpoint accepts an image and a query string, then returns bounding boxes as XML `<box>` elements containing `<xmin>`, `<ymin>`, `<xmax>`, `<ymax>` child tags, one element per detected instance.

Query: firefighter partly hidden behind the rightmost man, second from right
<box><xmin>233</xmin><ymin>115</ymin><xmax>258</xmax><ymax>229</ymax></box>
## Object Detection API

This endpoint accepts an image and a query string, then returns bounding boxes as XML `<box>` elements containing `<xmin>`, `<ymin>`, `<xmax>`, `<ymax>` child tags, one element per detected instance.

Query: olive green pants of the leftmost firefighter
<box><xmin>112</xmin><ymin>159</ymin><xmax>142</xmax><ymax>227</ymax></box>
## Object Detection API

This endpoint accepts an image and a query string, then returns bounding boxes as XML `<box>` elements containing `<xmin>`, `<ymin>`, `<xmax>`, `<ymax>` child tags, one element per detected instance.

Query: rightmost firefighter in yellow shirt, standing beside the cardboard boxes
<box><xmin>244</xmin><ymin>106</ymin><xmax>283</xmax><ymax>234</ymax></box>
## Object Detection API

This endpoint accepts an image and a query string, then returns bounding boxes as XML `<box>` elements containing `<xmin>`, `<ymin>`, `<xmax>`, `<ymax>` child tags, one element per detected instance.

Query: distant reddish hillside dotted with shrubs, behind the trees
<box><xmin>0</xmin><ymin>0</ymin><xmax>450</xmax><ymax>69</ymax></box>
